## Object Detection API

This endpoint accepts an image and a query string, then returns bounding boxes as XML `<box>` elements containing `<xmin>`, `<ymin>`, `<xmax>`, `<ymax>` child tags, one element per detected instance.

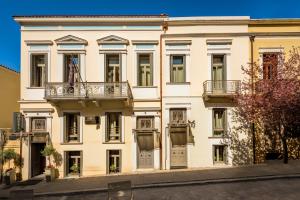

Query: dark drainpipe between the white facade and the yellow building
<box><xmin>249</xmin><ymin>35</ymin><xmax>256</xmax><ymax>164</ymax></box>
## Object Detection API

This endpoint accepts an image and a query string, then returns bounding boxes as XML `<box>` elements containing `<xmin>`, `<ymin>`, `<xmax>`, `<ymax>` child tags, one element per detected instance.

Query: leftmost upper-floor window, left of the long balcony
<box><xmin>30</xmin><ymin>54</ymin><xmax>47</xmax><ymax>87</ymax></box>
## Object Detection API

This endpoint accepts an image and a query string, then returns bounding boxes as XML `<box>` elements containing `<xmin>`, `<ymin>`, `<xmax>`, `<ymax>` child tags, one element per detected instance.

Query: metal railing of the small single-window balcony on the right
<box><xmin>203</xmin><ymin>80</ymin><xmax>241</xmax><ymax>95</ymax></box>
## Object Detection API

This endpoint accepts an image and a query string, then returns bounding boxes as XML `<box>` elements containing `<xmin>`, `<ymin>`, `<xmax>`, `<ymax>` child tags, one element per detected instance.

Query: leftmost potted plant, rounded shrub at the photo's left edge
<box><xmin>2</xmin><ymin>149</ymin><xmax>17</xmax><ymax>185</ymax></box>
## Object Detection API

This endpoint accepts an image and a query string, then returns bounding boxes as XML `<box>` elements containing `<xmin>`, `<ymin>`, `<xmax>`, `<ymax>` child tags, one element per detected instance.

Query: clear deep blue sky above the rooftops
<box><xmin>0</xmin><ymin>0</ymin><xmax>300</xmax><ymax>71</ymax></box>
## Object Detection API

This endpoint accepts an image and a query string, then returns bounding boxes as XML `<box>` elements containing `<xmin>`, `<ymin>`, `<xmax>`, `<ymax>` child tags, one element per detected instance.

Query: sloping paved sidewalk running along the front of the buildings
<box><xmin>0</xmin><ymin>160</ymin><xmax>300</xmax><ymax>198</ymax></box>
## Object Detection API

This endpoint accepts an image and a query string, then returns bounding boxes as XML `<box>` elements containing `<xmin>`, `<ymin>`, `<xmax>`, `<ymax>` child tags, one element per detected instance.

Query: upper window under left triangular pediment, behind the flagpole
<box><xmin>64</xmin><ymin>54</ymin><xmax>80</xmax><ymax>85</ymax></box>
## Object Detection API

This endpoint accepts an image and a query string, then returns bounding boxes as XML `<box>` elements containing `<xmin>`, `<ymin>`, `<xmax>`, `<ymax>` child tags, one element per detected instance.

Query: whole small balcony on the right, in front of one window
<box><xmin>203</xmin><ymin>80</ymin><xmax>241</xmax><ymax>101</ymax></box>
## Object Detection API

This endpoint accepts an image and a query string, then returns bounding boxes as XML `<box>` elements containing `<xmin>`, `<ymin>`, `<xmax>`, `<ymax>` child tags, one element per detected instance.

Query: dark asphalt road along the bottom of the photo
<box><xmin>35</xmin><ymin>179</ymin><xmax>300</xmax><ymax>200</ymax></box>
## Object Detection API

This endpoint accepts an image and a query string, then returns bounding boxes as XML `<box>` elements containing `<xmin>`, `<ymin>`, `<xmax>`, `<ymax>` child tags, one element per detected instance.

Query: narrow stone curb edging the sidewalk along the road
<box><xmin>34</xmin><ymin>173</ymin><xmax>300</xmax><ymax>197</ymax></box>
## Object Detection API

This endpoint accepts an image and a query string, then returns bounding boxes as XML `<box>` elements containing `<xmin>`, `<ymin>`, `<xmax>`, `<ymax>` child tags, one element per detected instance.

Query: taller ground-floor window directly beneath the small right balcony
<box><xmin>213</xmin><ymin>108</ymin><xmax>226</xmax><ymax>136</ymax></box>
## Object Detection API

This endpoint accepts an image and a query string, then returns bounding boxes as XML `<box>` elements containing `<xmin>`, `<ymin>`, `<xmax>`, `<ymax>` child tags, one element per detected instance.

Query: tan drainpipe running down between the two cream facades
<box><xmin>159</xmin><ymin>22</ymin><xmax>168</xmax><ymax>169</ymax></box>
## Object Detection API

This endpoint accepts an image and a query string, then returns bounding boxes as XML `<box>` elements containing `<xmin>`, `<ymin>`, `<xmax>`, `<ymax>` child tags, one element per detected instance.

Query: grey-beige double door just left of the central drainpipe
<box><xmin>137</xmin><ymin>133</ymin><xmax>154</xmax><ymax>169</ymax></box>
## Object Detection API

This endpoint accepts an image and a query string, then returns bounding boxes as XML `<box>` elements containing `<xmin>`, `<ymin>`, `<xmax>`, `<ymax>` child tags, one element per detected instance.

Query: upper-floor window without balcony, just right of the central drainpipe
<box><xmin>171</xmin><ymin>55</ymin><xmax>185</xmax><ymax>83</ymax></box>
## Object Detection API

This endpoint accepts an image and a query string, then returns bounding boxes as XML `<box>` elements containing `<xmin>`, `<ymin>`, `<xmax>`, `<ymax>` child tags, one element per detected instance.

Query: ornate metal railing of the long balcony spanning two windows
<box><xmin>45</xmin><ymin>82</ymin><xmax>132</xmax><ymax>100</ymax></box>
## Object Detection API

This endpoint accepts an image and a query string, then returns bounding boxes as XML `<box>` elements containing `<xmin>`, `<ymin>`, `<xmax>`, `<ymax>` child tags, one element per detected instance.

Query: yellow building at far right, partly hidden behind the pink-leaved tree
<box><xmin>249</xmin><ymin>19</ymin><xmax>300</xmax><ymax>162</ymax></box>
